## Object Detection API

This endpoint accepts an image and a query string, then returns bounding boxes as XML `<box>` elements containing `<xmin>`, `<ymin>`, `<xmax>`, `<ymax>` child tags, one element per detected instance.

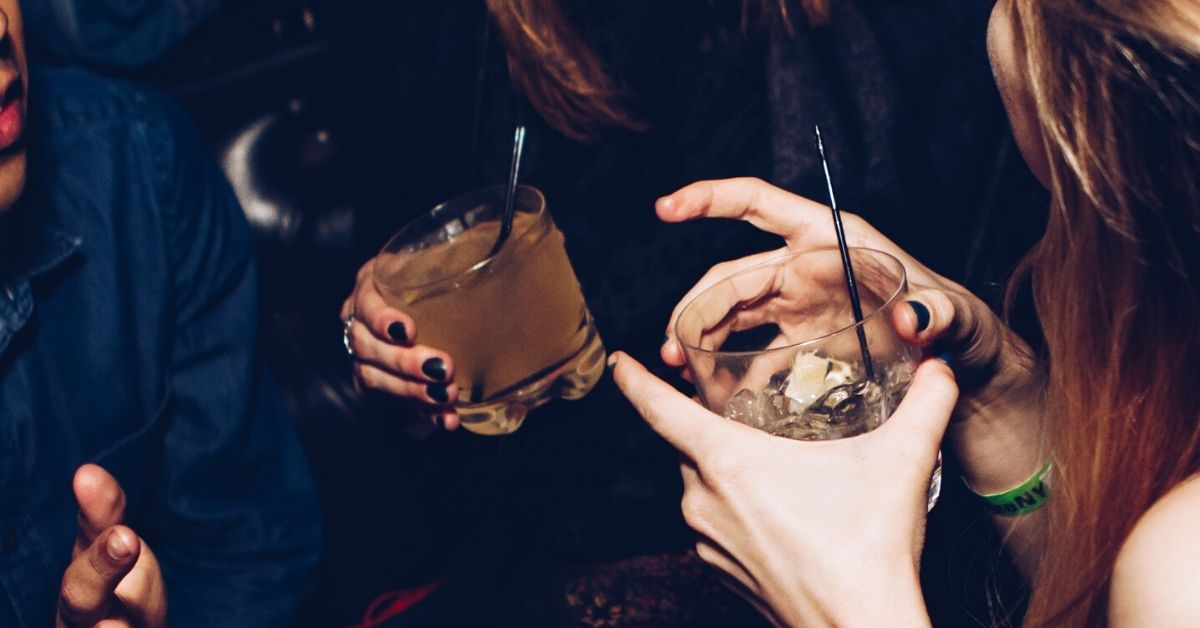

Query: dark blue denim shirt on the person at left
<box><xmin>0</xmin><ymin>70</ymin><xmax>320</xmax><ymax>627</ymax></box>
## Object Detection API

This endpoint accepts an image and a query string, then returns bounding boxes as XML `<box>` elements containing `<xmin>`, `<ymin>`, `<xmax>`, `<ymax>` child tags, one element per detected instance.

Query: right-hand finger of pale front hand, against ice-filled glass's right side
<box><xmin>876</xmin><ymin>359</ymin><xmax>959</xmax><ymax>451</ymax></box>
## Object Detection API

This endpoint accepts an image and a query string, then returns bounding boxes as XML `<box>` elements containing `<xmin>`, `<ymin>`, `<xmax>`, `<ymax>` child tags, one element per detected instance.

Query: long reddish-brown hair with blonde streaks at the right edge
<box><xmin>1012</xmin><ymin>0</ymin><xmax>1200</xmax><ymax>627</ymax></box>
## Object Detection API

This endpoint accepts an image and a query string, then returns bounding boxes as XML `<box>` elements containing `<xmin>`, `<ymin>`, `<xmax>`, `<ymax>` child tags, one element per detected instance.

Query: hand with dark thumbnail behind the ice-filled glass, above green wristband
<box><xmin>655</xmin><ymin>179</ymin><xmax>1044</xmax><ymax>482</ymax></box>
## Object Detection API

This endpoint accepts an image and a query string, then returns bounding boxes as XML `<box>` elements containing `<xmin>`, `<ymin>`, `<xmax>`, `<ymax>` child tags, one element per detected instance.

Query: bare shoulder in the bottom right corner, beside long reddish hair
<box><xmin>1109</xmin><ymin>477</ymin><xmax>1200</xmax><ymax>628</ymax></box>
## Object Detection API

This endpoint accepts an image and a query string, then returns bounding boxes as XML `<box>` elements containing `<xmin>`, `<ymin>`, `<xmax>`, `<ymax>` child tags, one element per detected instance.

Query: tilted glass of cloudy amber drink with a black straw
<box><xmin>374</xmin><ymin>185</ymin><xmax>605</xmax><ymax>435</ymax></box>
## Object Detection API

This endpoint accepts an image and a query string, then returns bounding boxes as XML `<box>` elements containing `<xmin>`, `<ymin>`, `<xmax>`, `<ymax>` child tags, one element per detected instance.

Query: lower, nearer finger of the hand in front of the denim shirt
<box><xmin>59</xmin><ymin>526</ymin><xmax>142</xmax><ymax>628</ymax></box>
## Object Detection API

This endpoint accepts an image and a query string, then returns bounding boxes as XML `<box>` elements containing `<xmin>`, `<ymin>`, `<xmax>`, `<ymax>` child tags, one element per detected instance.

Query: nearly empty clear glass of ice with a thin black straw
<box><xmin>676</xmin><ymin>249</ymin><xmax>941</xmax><ymax>508</ymax></box>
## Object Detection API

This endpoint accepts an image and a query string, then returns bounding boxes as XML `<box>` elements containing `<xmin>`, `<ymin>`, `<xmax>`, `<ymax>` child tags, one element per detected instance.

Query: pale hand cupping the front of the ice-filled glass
<box><xmin>610</xmin><ymin>353</ymin><xmax>958</xmax><ymax>626</ymax></box>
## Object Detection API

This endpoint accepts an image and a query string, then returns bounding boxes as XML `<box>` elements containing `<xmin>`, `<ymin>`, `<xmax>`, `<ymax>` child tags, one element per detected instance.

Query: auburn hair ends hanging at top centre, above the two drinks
<box><xmin>487</xmin><ymin>0</ymin><xmax>829</xmax><ymax>140</ymax></box>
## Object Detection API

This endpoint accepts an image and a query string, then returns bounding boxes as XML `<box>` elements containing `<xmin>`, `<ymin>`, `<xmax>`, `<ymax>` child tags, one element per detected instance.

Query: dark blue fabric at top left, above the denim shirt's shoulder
<box><xmin>20</xmin><ymin>0</ymin><xmax>221</xmax><ymax>70</ymax></box>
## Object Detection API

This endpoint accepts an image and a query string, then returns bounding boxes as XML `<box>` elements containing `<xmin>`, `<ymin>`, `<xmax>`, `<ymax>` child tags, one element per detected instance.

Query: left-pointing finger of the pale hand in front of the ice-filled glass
<box><xmin>608</xmin><ymin>352</ymin><xmax>742</xmax><ymax>460</ymax></box>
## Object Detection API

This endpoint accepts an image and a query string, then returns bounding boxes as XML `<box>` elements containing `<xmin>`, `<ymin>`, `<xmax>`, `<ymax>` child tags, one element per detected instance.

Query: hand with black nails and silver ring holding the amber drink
<box><xmin>342</xmin><ymin>259</ymin><xmax>458</xmax><ymax>430</ymax></box>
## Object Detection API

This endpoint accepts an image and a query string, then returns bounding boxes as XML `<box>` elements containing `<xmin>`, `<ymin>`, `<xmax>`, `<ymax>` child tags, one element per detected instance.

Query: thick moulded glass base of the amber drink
<box><xmin>457</xmin><ymin>325</ymin><xmax>607</xmax><ymax>436</ymax></box>
